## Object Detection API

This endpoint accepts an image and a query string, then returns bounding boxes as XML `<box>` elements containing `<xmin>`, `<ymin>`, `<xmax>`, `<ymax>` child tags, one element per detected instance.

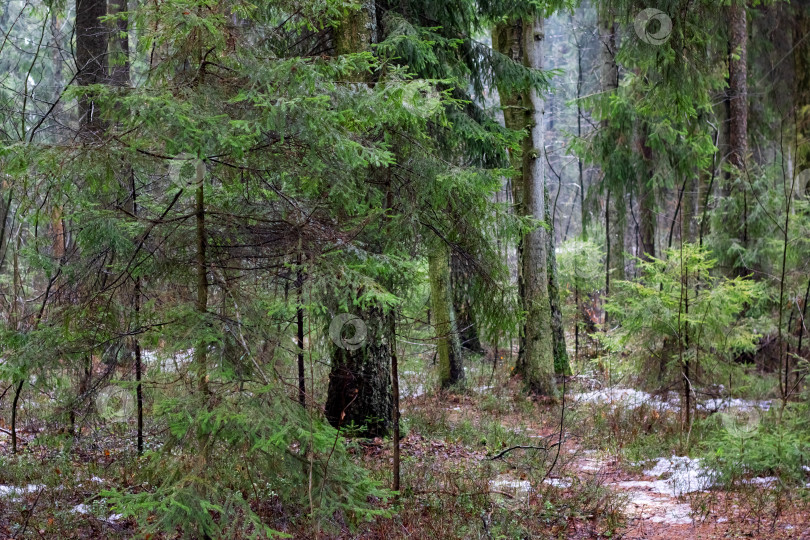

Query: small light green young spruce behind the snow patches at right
<box><xmin>606</xmin><ymin>244</ymin><xmax>763</xmax><ymax>384</ymax></box>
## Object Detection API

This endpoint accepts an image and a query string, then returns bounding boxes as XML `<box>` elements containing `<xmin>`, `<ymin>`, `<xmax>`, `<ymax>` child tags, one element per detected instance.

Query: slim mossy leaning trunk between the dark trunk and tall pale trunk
<box><xmin>428</xmin><ymin>238</ymin><xmax>464</xmax><ymax>388</ymax></box>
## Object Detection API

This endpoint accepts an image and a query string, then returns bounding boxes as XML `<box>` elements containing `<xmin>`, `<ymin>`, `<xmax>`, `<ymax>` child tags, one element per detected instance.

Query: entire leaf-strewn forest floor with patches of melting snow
<box><xmin>0</xmin><ymin>359</ymin><xmax>810</xmax><ymax>540</ymax></box>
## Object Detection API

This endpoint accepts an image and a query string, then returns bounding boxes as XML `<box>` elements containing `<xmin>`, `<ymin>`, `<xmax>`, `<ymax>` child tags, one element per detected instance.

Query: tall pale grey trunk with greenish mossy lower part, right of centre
<box><xmin>523</xmin><ymin>17</ymin><xmax>557</xmax><ymax>396</ymax></box>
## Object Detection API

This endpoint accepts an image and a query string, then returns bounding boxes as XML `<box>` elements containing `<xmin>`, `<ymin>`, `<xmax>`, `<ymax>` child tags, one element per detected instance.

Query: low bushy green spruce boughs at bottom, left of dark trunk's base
<box><xmin>101</xmin><ymin>386</ymin><xmax>389</xmax><ymax>538</ymax></box>
